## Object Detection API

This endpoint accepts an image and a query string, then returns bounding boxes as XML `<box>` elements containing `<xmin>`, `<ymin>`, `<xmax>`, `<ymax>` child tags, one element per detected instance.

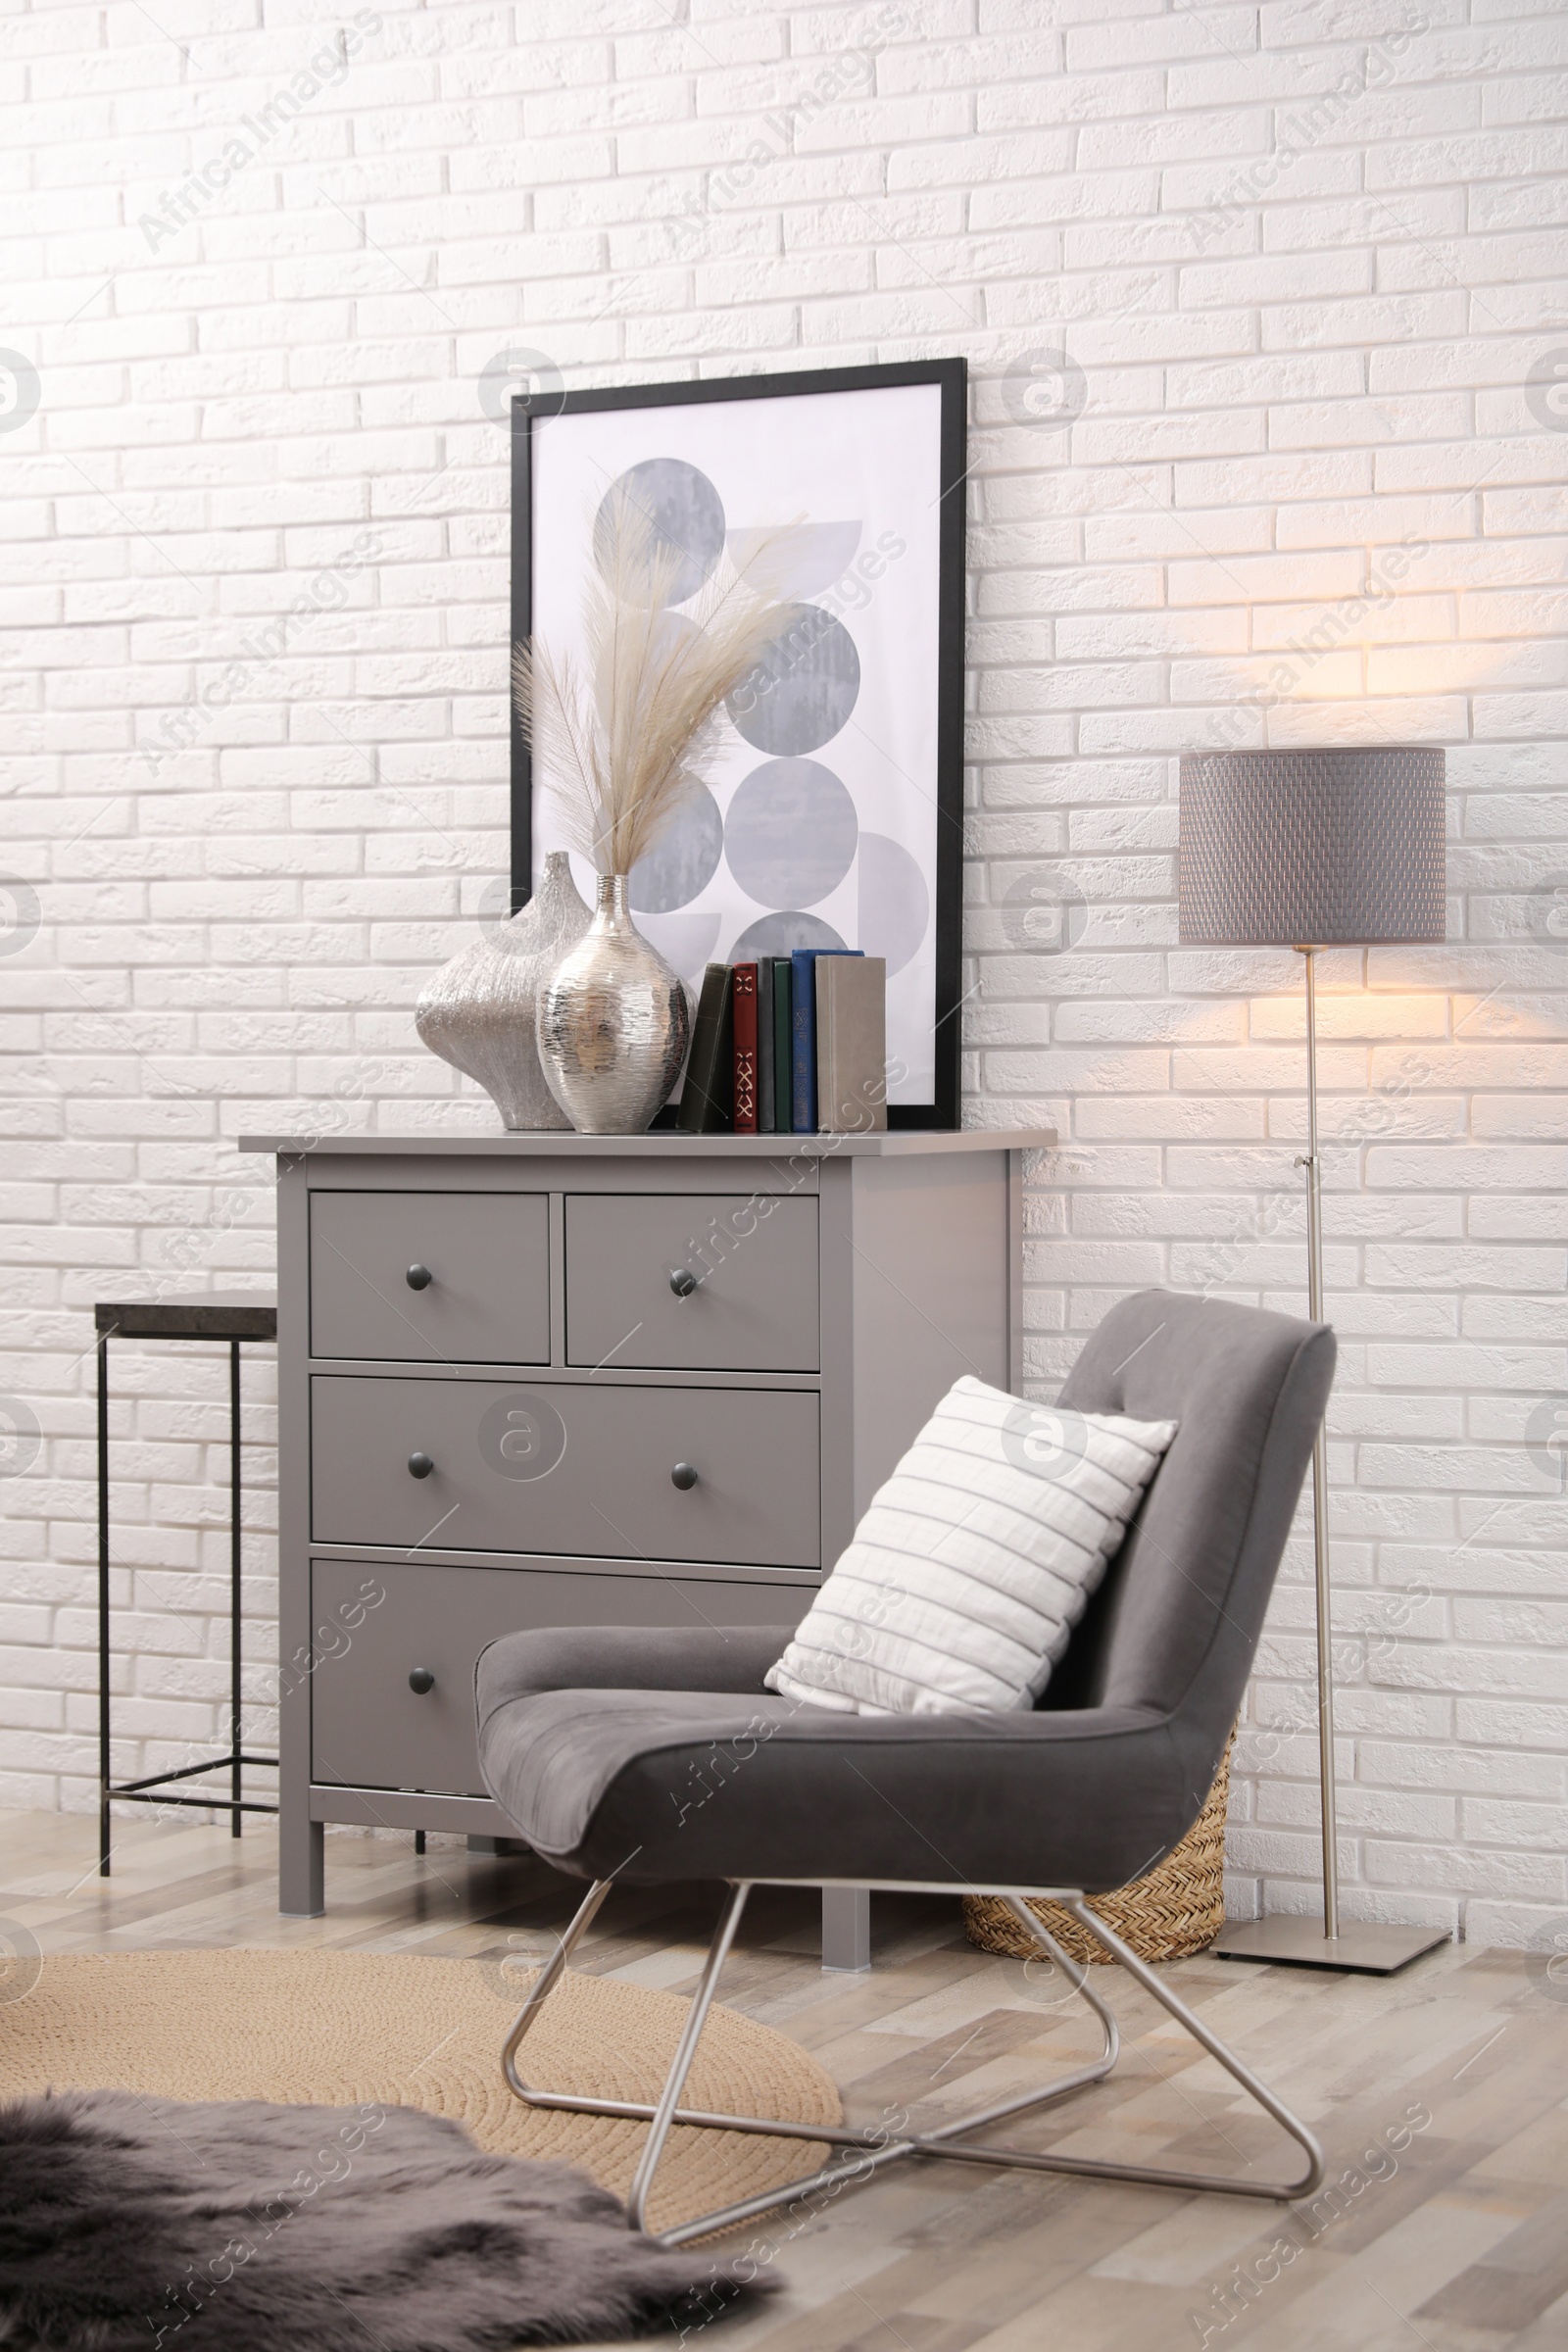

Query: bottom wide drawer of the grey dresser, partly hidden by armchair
<box><xmin>311</xmin><ymin>1559</ymin><xmax>811</xmax><ymax>1797</ymax></box>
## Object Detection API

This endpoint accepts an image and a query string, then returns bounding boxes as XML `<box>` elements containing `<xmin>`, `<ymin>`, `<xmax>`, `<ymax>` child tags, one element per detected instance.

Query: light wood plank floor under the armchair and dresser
<box><xmin>0</xmin><ymin>1813</ymin><xmax>1568</xmax><ymax>2352</ymax></box>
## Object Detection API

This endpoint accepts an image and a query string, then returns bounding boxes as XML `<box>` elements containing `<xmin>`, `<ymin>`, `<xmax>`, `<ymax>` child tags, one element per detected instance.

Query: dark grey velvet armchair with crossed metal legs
<box><xmin>477</xmin><ymin>1292</ymin><xmax>1336</xmax><ymax>2244</ymax></box>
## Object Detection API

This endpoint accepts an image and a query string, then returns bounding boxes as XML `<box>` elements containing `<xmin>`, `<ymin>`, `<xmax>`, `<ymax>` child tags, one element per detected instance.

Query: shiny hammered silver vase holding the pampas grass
<box><xmin>538</xmin><ymin>875</ymin><xmax>691</xmax><ymax>1136</ymax></box>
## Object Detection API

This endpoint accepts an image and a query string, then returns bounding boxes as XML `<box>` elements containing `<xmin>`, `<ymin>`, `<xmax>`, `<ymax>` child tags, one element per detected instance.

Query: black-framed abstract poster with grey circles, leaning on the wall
<box><xmin>513</xmin><ymin>360</ymin><xmax>966</xmax><ymax>1127</ymax></box>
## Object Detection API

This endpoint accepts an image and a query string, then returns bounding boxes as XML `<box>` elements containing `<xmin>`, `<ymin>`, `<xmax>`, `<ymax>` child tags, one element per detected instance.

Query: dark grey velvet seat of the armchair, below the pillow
<box><xmin>477</xmin><ymin>1625</ymin><xmax>1215</xmax><ymax>1893</ymax></box>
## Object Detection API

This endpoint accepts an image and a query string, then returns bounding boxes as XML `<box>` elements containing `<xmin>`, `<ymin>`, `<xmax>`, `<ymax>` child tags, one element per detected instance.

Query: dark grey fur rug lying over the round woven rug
<box><xmin>0</xmin><ymin>2091</ymin><xmax>773</xmax><ymax>2352</ymax></box>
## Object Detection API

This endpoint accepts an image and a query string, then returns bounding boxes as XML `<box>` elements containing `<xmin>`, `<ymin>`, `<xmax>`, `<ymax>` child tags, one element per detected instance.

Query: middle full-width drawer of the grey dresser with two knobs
<box><xmin>311</xmin><ymin>1374</ymin><xmax>820</xmax><ymax>1569</ymax></box>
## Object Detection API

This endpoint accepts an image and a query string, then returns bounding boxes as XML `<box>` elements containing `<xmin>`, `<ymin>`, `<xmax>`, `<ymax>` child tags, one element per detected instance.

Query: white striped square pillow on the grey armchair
<box><xmin>766</xmin><ymin>1378</ymin><xmax>1175</xmax><ymax>1715</ymax></box>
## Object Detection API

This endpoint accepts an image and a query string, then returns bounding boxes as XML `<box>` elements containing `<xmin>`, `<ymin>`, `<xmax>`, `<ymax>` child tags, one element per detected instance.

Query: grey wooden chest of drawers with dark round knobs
<box><xmin>244</xmin><ymin>1131</ymin><xmax>1055</xmax><ymax>1915</ymax></box>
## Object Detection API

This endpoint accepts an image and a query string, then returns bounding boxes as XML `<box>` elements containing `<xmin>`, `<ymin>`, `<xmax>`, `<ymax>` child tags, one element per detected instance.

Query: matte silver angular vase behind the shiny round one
<box><xmin>414</xmin><ymin>849</ymin><xmax>592</xmax><ymax>1134</ymax></box>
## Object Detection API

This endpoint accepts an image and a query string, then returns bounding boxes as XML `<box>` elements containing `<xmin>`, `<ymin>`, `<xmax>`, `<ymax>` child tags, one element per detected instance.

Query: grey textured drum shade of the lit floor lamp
<box><xmin>1180</xmin><ymin>746</ymin><xmax>1446</xmax><ymax>948</ymax></box>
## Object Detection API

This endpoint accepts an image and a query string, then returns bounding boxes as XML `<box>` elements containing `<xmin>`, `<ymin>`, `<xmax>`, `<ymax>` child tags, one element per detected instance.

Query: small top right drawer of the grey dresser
<box><xmin>566</xmin><ymin>1193</ymin><xmax>820</xmax><ymax>1371</ymax></box>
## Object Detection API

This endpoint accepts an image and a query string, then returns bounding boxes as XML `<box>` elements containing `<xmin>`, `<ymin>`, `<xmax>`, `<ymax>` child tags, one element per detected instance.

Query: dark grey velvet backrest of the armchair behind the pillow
<box><xmin>1042</xmin><ymin>1292</ymin><xmax>1336</xmax><ymax>1757</ymax></box>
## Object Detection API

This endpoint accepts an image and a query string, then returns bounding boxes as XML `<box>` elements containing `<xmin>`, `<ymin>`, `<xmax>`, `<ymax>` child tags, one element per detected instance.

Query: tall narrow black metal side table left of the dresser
<box><xmin>94</xmin><ymin>1292</ymin><xmax>277</xmax><ymax>1880</ymax></box>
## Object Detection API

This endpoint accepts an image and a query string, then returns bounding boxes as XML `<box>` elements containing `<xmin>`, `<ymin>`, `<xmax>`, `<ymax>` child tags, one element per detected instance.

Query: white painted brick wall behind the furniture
<box><xmin>0</xmin><ymin>0</ymin><xmax>1568</xmax><ymax>1942</ymax></box>
